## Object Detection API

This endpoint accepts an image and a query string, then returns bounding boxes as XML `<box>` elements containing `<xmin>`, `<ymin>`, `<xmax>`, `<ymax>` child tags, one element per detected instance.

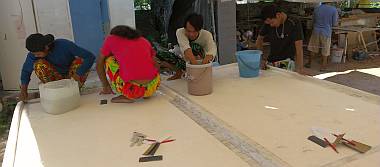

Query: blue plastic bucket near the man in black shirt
<box><xmin>236</xmin><ymin>50</ymin><xmax>263</xmax><ymax>78</ymax></box>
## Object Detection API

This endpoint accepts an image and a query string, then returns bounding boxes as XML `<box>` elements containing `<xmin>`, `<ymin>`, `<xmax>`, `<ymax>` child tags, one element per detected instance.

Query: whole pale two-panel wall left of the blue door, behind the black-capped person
<box><xmin>0</xmin><ymin>0</ymin><xmax>73</xmax><ymax>90</ymax></box>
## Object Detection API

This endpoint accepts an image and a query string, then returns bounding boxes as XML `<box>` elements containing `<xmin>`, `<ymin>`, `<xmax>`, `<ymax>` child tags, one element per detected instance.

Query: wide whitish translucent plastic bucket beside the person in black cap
<box><xmin>39</xmin><ymin>79</ymin><xmax>80</xmax><ymax>114</ymax></box>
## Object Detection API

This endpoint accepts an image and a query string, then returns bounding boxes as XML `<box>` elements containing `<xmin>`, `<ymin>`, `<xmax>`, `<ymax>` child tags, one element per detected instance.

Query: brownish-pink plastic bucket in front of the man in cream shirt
<box><xmin>186</xmin><ymin>62</ymin><xmax>212</xmax><ymax>96</ymax></box>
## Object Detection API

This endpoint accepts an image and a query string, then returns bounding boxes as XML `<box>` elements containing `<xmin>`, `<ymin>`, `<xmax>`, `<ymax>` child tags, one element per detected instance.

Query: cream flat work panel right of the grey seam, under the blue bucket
<box><xmin>164</xmin><ymin>64</ymin><xmax>380</xmax><ymax>167</ymax></box>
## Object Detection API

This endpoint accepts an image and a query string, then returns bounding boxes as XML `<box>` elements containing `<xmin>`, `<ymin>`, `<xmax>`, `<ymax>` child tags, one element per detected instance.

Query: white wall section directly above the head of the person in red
<box><xmin>108</xmin><ymin>0</ymin><xmax>136</xmax><ymax>28</ymax></box>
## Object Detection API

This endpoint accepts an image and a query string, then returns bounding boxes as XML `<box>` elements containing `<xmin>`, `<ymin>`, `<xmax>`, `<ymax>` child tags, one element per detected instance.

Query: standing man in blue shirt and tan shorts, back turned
<box><xmin>305</xmin><ymin>3</ymin><xmax>338</xmax><ymax>71</ymax></box>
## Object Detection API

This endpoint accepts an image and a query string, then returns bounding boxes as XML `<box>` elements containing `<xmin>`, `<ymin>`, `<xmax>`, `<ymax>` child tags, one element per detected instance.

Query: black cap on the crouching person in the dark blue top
<box><xmin>25</xmin><ymin>33</ymin><xmax>54</xmax><ymax>52</ymax></box>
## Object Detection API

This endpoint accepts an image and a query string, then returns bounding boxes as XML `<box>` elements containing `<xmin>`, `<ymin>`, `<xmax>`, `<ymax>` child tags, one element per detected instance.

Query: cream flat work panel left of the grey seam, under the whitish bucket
<box><xmin>14</xmin><ymin>94</ymin><xmax>248</xmax><ymax>167</ymax></box>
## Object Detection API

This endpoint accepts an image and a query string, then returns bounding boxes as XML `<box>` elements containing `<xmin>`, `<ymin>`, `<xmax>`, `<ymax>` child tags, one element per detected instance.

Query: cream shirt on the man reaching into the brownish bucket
<box><xmin>176</xmin><ymin>28</ymin><xmax>217</xmax><ymax>57</ymax></box>
